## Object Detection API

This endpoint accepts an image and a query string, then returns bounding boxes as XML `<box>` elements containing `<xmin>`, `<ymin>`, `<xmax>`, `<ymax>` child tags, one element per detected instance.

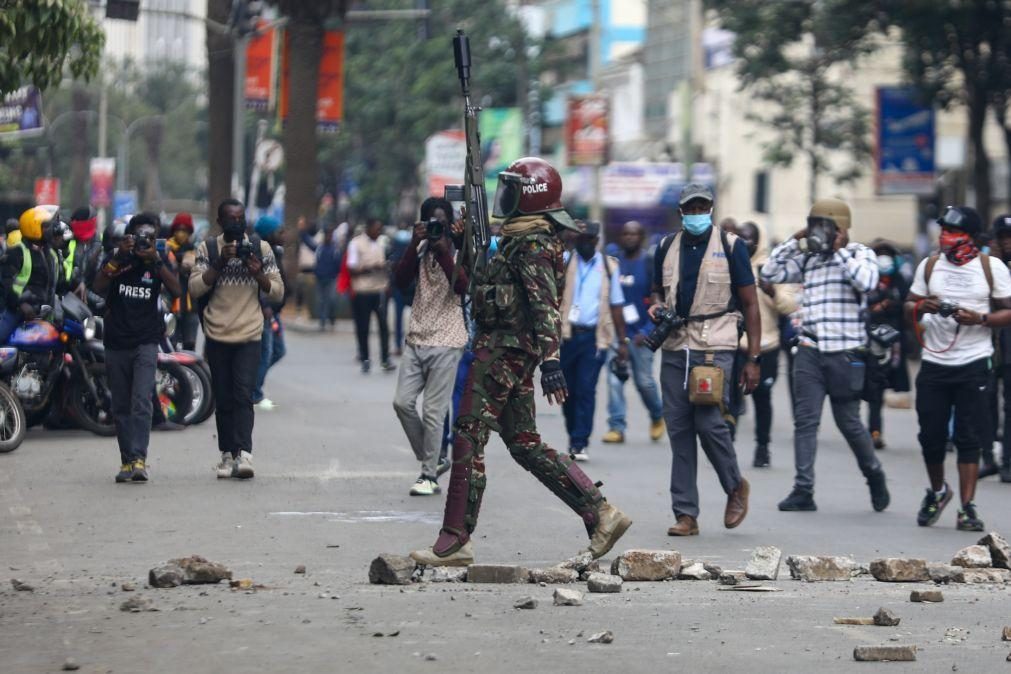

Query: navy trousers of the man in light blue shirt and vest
<box><xmin>561</xmin><ymin>329</ymin><xmax>607</xmax><ymax>450</ymax></box>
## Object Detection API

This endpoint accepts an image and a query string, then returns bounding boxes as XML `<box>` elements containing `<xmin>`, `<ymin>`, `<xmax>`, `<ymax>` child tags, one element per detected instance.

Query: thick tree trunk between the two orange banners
<box><xmin>284</xmin><ymin>17</ymin><xmax>324</xmax><ymax>281</ymax></box>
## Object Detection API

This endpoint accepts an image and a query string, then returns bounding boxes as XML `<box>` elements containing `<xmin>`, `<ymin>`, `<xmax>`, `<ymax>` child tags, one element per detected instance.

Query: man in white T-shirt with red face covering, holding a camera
<box><xmin>906</xmin><ymin>206</ymin><xmax>1011</xmax><ymax>532</ymax></box>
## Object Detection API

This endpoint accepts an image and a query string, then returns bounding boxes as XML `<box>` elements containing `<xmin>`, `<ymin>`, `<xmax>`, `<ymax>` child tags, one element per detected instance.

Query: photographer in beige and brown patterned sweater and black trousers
<box><xmin>189</xmin><ymin>199</ymin><xmax>284</xmax><ymax>479</ymax></box>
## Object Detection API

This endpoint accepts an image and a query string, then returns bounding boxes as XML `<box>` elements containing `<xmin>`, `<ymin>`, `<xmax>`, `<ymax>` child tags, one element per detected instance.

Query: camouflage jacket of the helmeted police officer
<box><xmin>474</xmin><ymin>231</ymin><xmax>565</xmax><ymax>361</ymax></box>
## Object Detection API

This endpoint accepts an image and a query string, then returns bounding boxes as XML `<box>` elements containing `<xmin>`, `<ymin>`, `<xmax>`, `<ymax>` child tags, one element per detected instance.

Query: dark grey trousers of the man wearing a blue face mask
<box><xmin>660</xmin><ymin>351</ymin><xmax>742</xmax><ymax>517</ymax></box>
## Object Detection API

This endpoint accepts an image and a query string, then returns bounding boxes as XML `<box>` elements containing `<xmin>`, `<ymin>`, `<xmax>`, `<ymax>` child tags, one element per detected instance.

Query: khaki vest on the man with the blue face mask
<box><xmin>663</xmin><ymin>226</ymin><xmax>741</xmax><ymax>351</ymax></box>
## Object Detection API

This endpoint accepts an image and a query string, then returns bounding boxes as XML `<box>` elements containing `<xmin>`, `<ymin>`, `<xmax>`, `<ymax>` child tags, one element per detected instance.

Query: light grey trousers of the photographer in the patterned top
<box><xmin>393</xmin><ymin>344</ymin><xmax>463</xmax><ymax>480</ymax></box>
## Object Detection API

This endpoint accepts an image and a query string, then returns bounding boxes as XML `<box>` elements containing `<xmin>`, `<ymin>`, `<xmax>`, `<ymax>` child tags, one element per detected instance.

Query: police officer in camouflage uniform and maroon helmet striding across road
<box><xmin>410</xmin><ymin>157</ymin><xmax>632</xmax><ymax>566</ymax></box>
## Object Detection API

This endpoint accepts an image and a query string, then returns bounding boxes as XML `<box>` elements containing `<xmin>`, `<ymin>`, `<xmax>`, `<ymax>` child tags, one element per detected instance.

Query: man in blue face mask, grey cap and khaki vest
<box><xmin>649</xmin><ymin>184</ymin><xmax>761</xmax><ymax>536</ymax></box>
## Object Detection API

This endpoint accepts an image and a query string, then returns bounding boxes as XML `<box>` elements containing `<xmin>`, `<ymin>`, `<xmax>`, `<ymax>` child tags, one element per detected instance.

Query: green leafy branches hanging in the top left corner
<box><xmin>0</xmin><ymin>0</ymin><xmax>105</xmax><ymax>95</ymax></box>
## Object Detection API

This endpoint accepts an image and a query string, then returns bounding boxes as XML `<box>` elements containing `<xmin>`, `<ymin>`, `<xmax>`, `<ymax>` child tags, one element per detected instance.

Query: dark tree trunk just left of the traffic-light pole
<box><xmin>207</xmin><ymin>0</ymin><xmax>236</xmax><ymax>226</ymax></box>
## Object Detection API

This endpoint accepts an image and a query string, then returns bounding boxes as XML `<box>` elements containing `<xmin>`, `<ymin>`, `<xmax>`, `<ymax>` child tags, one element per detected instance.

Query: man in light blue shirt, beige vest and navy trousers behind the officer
<box><xmin>559</xmin><ymin>222</ymin><xmax>628</xmax><ymax>461</ymax></box>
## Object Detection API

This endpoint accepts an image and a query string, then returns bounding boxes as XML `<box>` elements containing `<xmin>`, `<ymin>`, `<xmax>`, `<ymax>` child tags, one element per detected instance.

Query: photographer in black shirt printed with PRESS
<box><xmin>95</xmin><ymin>213</ymin><xmax>181</xmax><ymax>482</ymax></box>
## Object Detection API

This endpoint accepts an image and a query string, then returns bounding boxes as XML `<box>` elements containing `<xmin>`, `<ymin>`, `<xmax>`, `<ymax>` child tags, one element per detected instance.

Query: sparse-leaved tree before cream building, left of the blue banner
<box><xmin>706</xmin><ymin>0</ymin><xmax>883</xmax><ymax>201</ymax></box>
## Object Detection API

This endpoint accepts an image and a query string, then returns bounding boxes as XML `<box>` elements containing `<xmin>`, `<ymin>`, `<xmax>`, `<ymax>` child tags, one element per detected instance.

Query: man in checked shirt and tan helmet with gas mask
<box><xmin>761</xmin><ymin>198</ymin><xmax>891</xmax><ymax>512</ymax></box>
